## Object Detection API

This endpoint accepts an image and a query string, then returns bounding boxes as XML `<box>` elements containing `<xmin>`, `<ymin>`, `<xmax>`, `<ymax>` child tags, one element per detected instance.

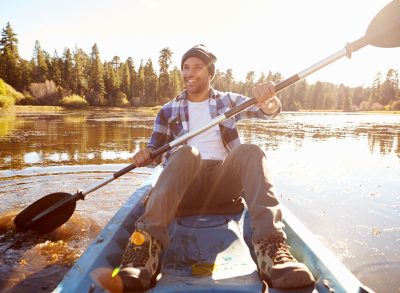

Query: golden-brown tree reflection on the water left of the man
<box><xmin>0</xmin><ymin>111</ymin><xmax>153</xmax><ymax>170</ymax></box>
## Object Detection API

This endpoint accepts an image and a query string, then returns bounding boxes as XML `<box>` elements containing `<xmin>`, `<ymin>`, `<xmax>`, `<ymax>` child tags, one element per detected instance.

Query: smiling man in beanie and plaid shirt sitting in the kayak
<box><xmin>119</xmin><ymin>45</ymin><xmax>314</xmax><ymax>290</ymax></box>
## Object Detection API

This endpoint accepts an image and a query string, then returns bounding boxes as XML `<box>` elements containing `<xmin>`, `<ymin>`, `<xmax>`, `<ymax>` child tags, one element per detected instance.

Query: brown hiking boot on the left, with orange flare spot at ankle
<box><xmin>118</xmin><ymin>230</ymin><xmax>162</xmax><ymax>290</ymax></box>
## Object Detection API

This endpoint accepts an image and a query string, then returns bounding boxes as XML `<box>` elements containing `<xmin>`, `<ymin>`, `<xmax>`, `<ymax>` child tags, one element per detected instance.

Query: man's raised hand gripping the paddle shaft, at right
<box><xmin>252</xmin><ymin>81</ymin><xmax>281</xmax><ymax>115</ymax></box>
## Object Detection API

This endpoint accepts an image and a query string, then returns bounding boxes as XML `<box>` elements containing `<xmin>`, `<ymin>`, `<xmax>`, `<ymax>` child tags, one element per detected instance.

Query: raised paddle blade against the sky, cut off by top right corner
<box><xmin>365</xmin><ymin>0</ymin><xmax>400</xmax><ymax>48</ymax></box>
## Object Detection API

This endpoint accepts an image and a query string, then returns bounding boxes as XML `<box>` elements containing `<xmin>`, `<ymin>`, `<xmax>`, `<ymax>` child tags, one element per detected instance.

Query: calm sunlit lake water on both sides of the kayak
<box><xmin>0</xmin><ymin>108</ymin><xmax>400</xmax><ymax>292</ymax></box>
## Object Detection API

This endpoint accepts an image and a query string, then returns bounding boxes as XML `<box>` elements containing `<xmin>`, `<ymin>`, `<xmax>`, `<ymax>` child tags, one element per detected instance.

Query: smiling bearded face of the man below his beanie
<box><xmin>182</xmin><ymin>57</ymin><xmax>211</xmax><ymax>94</ymax></box>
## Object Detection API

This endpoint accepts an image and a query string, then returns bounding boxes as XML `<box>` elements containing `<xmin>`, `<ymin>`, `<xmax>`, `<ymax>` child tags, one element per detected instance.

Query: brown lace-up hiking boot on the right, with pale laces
<box><xmin>254</xmin><ymin>236</ymin><xmax>315</xmax><ymax>289</ymax></box>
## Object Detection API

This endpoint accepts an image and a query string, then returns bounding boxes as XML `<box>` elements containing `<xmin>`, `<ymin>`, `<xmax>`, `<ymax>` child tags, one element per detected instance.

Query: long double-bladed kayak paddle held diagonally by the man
<box><xmin>14</xmin><ymin>0</ymin><xmax>400</xmax><ymax>233</ymax></box>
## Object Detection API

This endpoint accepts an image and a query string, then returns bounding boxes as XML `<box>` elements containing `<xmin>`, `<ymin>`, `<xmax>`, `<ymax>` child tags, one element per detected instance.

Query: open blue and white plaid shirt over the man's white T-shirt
<box><xmin>148</xmin><ymin>88</ymin><xmax>281</xmax><ymax>157</ymax></box>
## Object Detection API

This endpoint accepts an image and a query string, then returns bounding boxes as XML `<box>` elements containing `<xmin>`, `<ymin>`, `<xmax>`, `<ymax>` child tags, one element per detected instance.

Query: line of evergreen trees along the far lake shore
<box><xmin>0</xmin><ymin>23</ymin><xmax>400</xmax><ymax>111</ymax></box>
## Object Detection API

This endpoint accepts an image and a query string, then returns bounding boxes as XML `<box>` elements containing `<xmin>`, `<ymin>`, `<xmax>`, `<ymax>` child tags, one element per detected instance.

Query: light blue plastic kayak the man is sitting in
<box><xmin>53</xmin><ymin>168</ymin><xmax>372</xmax><ymax>293</ymax></box>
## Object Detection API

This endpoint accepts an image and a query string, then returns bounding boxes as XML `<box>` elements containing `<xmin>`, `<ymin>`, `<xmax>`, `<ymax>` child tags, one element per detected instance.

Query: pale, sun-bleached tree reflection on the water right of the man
<box><xmin>241</xmin><ymin>113</ymin><xmax>400</xmax><ymax>157</ymax></box>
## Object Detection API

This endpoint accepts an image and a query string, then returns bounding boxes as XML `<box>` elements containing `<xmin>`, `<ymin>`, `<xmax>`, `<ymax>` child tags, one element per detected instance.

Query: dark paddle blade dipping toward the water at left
<box><xmin>14</xmin><ymin>192</ymin><xmax>76</xmax><ymax>234</ymax></box>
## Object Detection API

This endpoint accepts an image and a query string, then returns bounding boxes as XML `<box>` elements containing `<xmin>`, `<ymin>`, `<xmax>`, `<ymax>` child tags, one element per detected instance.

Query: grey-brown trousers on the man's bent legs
<box><xmin>136</xmin><ymin>144</ymin><xmax>286</xmax><ymax>248</ymax></box>
